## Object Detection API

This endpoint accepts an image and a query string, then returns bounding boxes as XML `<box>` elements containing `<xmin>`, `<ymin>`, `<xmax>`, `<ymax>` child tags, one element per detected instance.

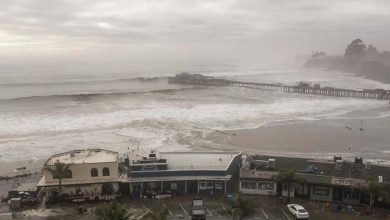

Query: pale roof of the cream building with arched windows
<box><xmin>46</xmin><ymin>149</ymin><xmax>118</xmax><ymax>165</ymax></box>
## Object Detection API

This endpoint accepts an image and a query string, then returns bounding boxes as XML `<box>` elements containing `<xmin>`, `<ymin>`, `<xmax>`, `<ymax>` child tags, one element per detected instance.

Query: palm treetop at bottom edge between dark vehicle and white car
<box><xmin>233</xmin><ymin>194</ymin><xmax>256</xmax><ymax>220</ymax></box>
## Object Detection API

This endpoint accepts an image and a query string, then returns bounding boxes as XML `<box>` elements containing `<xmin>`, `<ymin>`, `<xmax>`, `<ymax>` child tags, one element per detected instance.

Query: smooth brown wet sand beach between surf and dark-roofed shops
<box><xmin>207</xmin><ymin>108</ymin><xmax>390</xmax><ymax>163</ymax></box>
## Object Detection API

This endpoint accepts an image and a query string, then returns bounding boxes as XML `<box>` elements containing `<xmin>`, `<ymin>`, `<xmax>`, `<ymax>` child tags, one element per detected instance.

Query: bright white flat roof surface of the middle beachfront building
<box><xmin>160</xmin><ymin>151</ymin><xmax>241</xmax><ymax>170</ymax></box>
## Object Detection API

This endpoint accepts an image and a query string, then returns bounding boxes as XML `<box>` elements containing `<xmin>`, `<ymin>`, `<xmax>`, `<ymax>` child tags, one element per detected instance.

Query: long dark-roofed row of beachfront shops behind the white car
<box><xmin>240</xmin><ymin>155</ymin><xmax>390</xmax><ymax>204</ymax></box>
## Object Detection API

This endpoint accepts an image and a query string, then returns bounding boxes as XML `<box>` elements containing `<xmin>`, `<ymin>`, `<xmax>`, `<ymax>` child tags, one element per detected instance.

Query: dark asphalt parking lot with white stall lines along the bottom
<box><xmin>0</xmin><ymin>196</ymin><xmax>390</xmax><ymax>220</ymax></box>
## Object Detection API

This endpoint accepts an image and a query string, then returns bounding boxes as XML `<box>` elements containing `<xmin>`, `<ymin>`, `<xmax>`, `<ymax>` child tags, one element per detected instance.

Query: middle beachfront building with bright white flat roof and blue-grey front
<box><xmin>128</xmin><ymin>151</ymin><xmax>241</xmax><ymax>197</ymax></box>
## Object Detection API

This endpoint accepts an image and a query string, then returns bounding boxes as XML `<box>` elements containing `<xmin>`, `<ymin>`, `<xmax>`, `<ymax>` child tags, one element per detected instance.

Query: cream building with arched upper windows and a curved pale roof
<box><xmin>37</xmin><ymin>149</ymin><xmax>119</xmax><ymax>199</ymax></box>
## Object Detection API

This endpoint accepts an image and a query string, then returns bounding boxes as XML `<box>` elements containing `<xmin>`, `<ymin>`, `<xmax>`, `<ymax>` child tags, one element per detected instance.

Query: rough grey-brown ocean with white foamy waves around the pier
<box><xmin>0</xmin><ymin>67</ymin><xmax>390</xmax><ymax>168</ymax></box>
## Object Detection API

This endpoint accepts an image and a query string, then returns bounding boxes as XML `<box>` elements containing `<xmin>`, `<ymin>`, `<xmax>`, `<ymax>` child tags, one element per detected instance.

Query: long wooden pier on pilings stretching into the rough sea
<box><xmin>168</xmin><ymin>73</ymin><xmax>390</xmax><ymax>100</ymax></box>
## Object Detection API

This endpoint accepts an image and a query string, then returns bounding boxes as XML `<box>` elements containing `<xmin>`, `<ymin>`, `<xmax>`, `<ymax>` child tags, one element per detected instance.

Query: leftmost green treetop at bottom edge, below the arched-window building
<box><xmin>95</xmin><ymin>200</ymin><xmax>130</xmax><ymax>220</ymax></box>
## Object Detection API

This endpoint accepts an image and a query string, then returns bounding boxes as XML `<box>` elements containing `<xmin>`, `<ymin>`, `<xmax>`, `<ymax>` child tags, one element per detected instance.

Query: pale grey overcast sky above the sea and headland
<box><xmin>0</xmin><ymin>0</ymin><xmax>390</xmax><ymax>74</ymax></box>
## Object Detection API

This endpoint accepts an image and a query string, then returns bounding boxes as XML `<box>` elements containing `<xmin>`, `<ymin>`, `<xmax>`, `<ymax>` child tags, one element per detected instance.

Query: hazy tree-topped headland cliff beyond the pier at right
<box><xmin>304</xmin><ymin>39</ymin><xmax>390</xmax><ymax>83</ymax></box>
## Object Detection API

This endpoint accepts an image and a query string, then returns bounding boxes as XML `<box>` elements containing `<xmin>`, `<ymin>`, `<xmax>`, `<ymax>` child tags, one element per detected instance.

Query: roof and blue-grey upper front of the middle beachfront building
<box><xmin>129</xmin><ymin>151</ymin><xmax>241</xmax><ymax>181</ymax></box>
